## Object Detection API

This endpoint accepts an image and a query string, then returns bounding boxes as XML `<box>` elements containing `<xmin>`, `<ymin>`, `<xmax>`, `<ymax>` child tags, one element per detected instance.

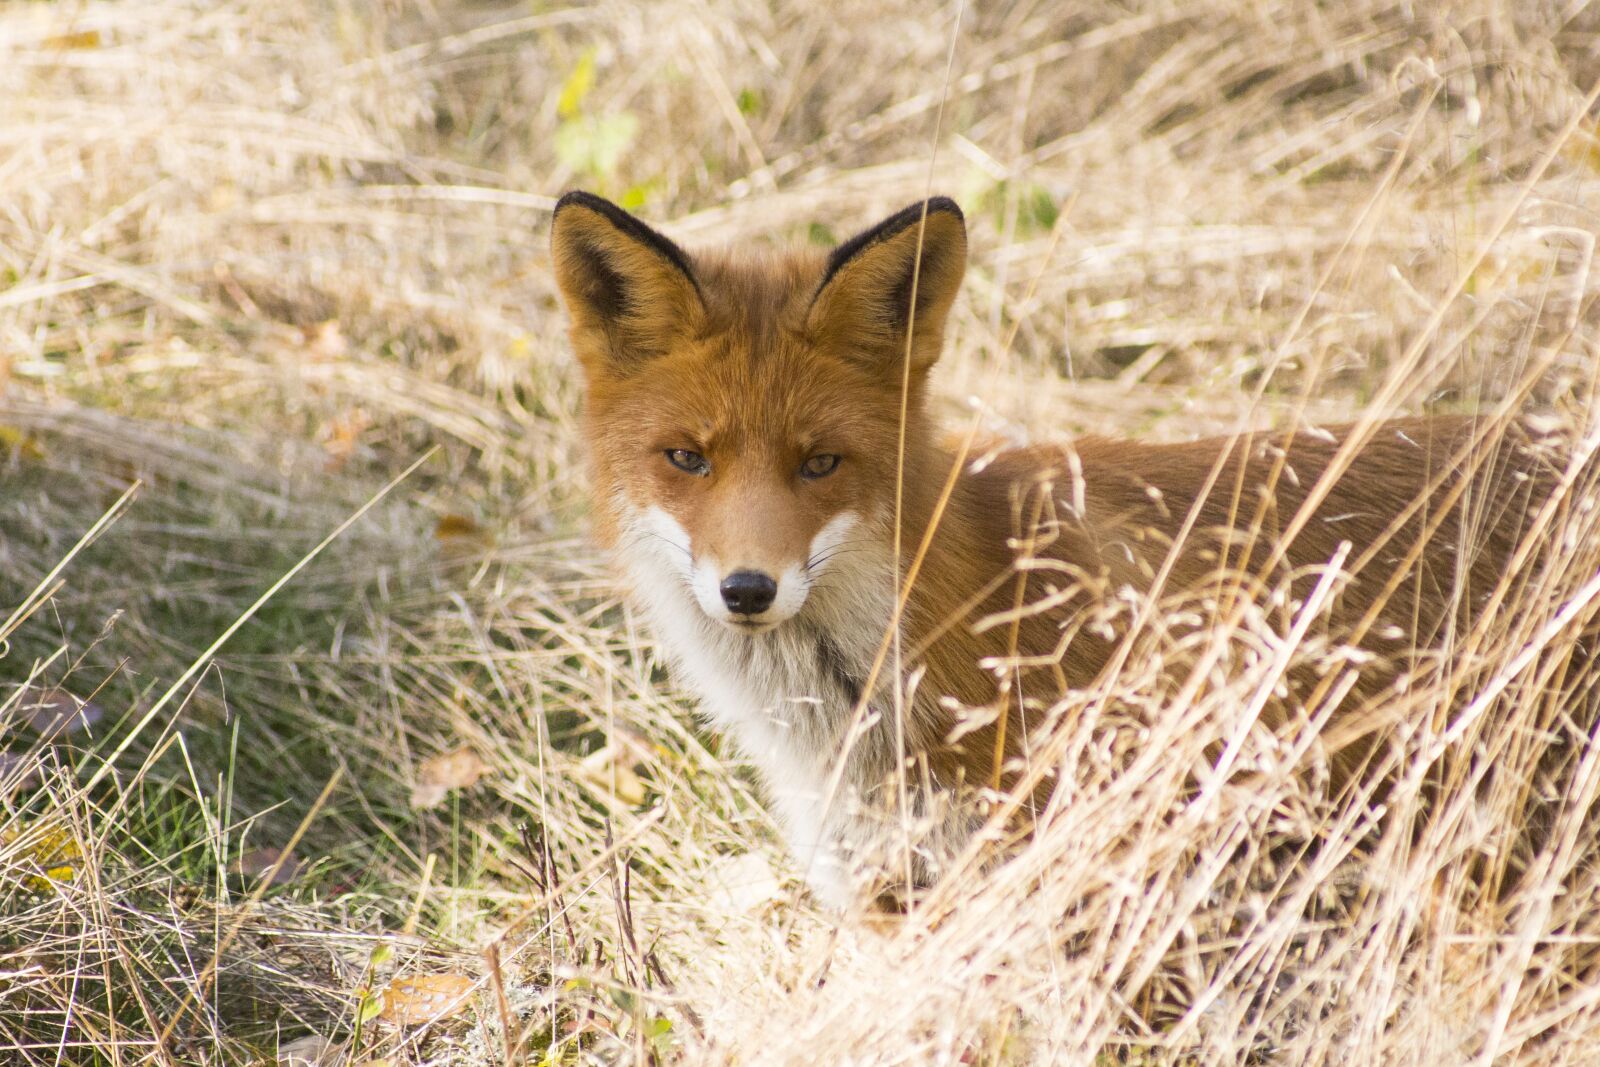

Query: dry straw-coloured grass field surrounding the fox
<box><xmin>0</xmin><ymin>0</ymin><xmax>1600</xmax><ymax>1067</ymax></box>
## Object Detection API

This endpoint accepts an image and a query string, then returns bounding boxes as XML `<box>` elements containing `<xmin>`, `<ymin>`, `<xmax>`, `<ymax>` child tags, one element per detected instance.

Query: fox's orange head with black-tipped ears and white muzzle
<box><xmin>550</xmin><ymin>192</ymin><xmax>966</xmax><ymax>633</ymax></box>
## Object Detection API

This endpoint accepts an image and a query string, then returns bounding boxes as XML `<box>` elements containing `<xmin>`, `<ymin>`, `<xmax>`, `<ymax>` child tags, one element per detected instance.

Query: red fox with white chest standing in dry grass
<box><xmin>552</xmin><ymin>192</ymin><xmax>1587</xmax><ymax>907</ymax></box>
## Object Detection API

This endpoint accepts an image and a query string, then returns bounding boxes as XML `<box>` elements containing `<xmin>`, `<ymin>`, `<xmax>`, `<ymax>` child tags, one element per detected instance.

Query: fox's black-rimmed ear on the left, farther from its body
<box><xmin>550</xmin><ymin>192</ymin><xmax>706</xmax><ymax>374</ymax></box>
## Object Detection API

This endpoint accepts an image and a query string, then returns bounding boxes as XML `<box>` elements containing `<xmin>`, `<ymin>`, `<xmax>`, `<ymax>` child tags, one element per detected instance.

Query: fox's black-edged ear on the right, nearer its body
<box><xmin>806</xmin><ymin>197</ymin><xmax>966</xmax><ymax>374</ymax></box>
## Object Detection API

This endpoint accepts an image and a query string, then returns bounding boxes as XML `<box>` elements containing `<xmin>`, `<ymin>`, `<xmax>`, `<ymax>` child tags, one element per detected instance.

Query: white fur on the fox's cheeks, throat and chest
<box><xmin>618</xmin><ymin>509</ymin><xmax>899</xmax><ymax>907</ymax></box>
